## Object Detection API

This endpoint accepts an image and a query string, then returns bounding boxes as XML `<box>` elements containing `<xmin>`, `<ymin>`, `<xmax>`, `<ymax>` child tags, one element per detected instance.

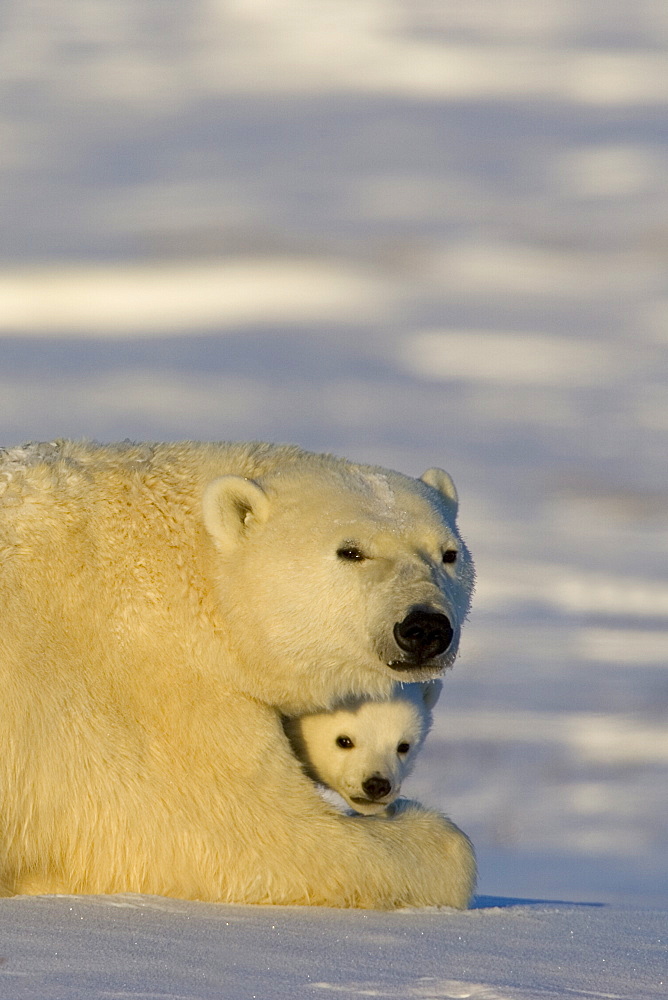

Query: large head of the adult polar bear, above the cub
<box><xmin>202</xmin><ymin>455</ymin><xmax>474</xmax><ymax>715</ymax></box>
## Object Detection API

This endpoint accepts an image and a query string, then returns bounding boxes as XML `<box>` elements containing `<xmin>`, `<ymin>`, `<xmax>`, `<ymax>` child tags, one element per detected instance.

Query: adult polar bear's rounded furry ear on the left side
<box><xmin>202</xmin><ymin>476</ymin><xmax>269</xmax><ymax>552</ymax></box>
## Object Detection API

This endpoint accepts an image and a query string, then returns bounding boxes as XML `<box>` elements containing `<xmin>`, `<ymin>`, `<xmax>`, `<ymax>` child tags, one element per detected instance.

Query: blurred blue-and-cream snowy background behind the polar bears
<box><xmin>0</xmin><ymin>0</ymin><xmax>668</xmax><ymax>906</ymax></box>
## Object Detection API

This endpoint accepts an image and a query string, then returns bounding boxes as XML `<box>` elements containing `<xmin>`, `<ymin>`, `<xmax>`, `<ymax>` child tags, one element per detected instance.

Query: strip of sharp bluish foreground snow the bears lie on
<box><xmin>0</xmin><ymin>896</ymin><xmax>667</xmax><ymax>1000</ymax></box>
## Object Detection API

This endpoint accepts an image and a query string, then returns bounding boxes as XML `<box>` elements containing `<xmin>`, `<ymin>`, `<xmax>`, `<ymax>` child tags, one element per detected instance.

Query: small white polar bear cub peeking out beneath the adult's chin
<box><xmin>284</xmin><ymin>680</ymin><xmax>442</xmax><ymax>815</ymax></box>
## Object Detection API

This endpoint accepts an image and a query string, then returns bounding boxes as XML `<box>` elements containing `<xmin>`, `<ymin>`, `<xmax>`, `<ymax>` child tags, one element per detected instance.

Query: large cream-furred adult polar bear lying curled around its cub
<box><xmin>0</xmin><ymin>441</ymin><xmax>475</xmax><ymax>908</ymax></box>
